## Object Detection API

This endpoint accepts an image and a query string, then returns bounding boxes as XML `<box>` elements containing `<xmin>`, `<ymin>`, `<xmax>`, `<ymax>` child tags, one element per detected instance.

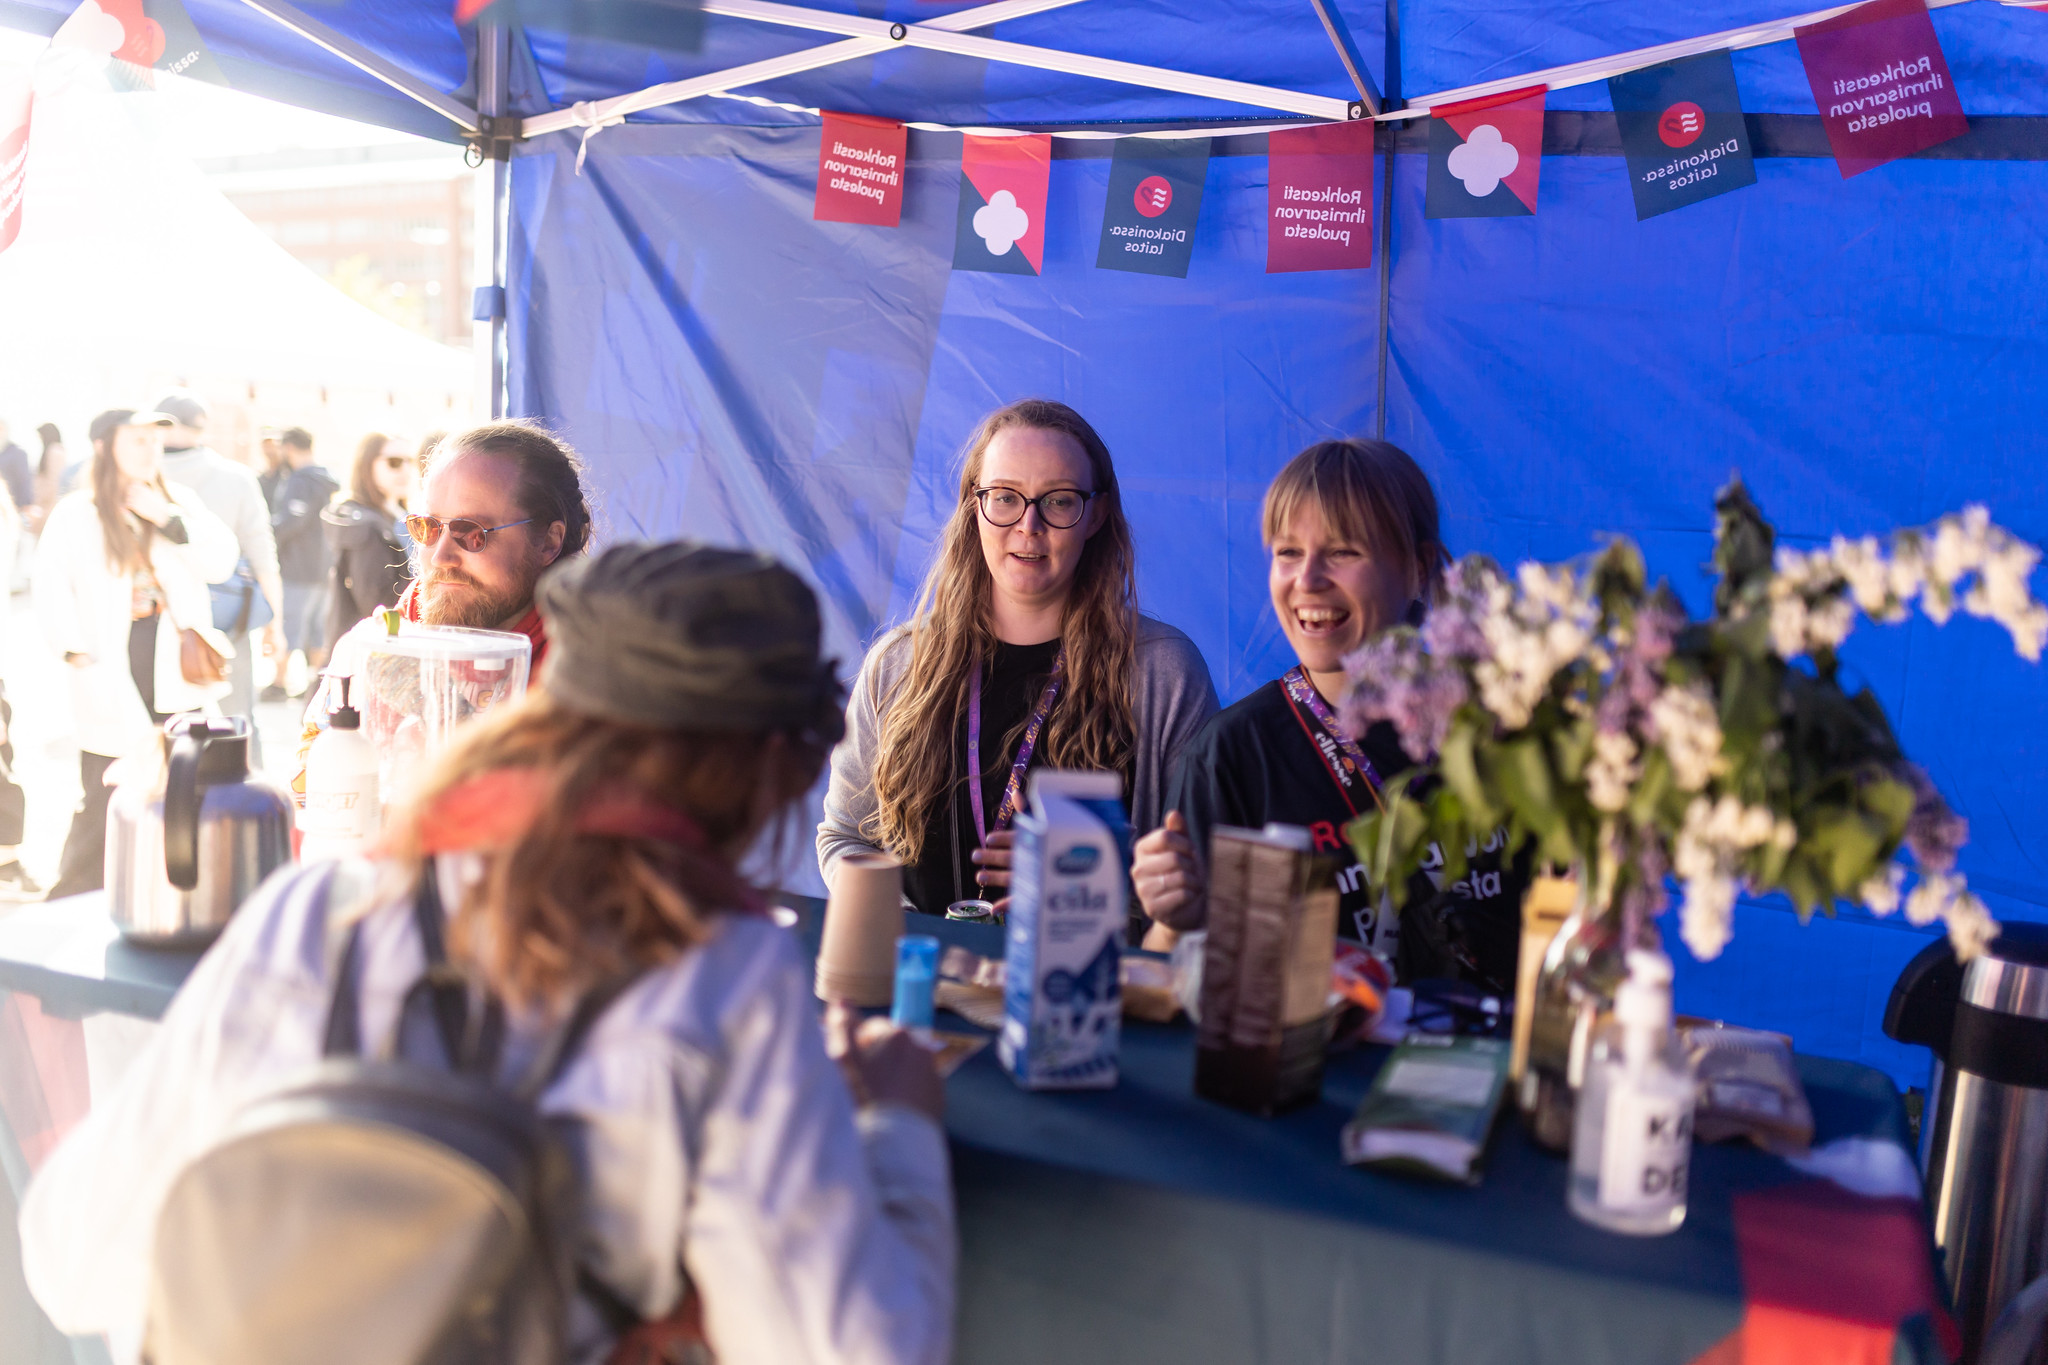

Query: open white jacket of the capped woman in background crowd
<box><xmin>33</xmin><ymin>483</ymin><xmax>240</xmax><ymax>757</ymax></box>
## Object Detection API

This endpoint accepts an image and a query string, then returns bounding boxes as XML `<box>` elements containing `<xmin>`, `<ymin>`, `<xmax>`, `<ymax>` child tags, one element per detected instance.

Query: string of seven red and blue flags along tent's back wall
<box><xmin>794</xmin><ymin>0</ymin><xmax>1998</xmax><ymax>278</ymax></box>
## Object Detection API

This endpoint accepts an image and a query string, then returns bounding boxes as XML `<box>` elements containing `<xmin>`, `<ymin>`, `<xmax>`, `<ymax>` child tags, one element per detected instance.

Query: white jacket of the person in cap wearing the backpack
<box><xmin>20</xmin><ymin>857</ymin><xmax>954</xmax><ymax>1365</ymax></box>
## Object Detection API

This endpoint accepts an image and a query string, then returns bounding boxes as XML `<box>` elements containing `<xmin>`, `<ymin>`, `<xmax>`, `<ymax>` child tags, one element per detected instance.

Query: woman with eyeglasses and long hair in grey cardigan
<box><xmin>817</xmin><ymin>399</ymin><xmax>1217</xmax><ymax>915</ymax></box>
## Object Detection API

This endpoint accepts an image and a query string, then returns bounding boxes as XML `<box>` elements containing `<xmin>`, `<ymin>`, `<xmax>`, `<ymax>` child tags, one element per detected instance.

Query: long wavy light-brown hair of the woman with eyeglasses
<box><xmin>862</xmin><ymin>399</ymin><xmax>1139</xmax><ymax>862</ymax></box>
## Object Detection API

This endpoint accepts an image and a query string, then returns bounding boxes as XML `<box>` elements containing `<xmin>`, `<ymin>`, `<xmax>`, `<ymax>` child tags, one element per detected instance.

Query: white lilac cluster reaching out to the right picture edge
<box><xmin>1769</xmin><ymin>505</ymin><xmax>2048</xmax><ymax>661</ymax></box>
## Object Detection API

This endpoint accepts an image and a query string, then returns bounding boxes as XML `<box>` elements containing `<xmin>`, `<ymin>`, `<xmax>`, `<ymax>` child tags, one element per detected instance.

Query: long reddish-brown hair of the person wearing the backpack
<box><xmin>389</xmin><ymin>692</ymin><xmax>825</xmax><ymax>1005</ymax></box>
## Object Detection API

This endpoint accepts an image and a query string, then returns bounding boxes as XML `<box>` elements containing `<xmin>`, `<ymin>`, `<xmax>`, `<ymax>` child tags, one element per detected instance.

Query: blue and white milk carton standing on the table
<box><xmin>997</xmin><ymin>772</ymin><xmax>1130</xmax><ymax>1091</ymax></box>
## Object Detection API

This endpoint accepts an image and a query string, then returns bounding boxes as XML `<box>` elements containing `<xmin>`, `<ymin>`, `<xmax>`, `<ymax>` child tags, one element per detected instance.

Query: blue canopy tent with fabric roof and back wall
<box><xmin>0</xmin><ymin>0</ymin><xmax>2048</xmax><ymax>1081</ymax></box>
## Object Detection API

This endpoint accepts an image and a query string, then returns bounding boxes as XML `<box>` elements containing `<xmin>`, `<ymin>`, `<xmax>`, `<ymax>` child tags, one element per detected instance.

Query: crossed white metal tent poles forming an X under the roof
<box><xmin>520</xmin><ymin>0</ymin><xmax>1352</xmax><ymax>137</ymax></box>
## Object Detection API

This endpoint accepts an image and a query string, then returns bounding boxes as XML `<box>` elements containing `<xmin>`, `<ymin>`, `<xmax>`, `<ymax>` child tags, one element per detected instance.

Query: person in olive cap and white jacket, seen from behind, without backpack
<box><xmin>20</xmin><ymin>542</ymin><xmax>956</xmax><ymax>1365</ymax></box>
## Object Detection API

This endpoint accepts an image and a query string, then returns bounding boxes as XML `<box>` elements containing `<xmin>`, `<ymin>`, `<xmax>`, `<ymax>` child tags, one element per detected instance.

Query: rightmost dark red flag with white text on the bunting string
<box><xmin>1794</xmin><ymin>0</ymin><xmax>1970</xmax><ymax>178</ymax></box>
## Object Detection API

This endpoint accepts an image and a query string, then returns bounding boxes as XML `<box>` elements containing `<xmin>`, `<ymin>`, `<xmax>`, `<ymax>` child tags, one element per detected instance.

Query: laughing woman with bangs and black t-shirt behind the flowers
<box><xmin>1133</xmin><ymin>440</ymin><xmax>1524</xmax><ymax>993</ymax></box>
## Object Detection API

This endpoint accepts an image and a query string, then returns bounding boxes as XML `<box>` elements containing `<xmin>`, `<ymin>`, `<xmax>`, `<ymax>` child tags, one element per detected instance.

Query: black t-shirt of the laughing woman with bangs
<box><xmin>1165</xmin><ymin>681</ymin><xmax>1524</xmax><ymax>990</ymax></box>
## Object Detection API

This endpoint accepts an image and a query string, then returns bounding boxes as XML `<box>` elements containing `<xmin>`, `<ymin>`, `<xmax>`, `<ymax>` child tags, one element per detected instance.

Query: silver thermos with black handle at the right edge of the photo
<box><xmin>1884</xmin><ymin>923</ymin><xmax>2048</xmax><ymax>1365</ymax></box>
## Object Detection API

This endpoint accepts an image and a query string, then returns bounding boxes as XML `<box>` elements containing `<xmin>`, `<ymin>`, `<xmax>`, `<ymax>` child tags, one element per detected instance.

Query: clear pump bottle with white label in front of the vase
<box><xmin>1569</xmin><ymin>948</ymin><xmax>1694</xmax><ymax>1236</ymax></box>
